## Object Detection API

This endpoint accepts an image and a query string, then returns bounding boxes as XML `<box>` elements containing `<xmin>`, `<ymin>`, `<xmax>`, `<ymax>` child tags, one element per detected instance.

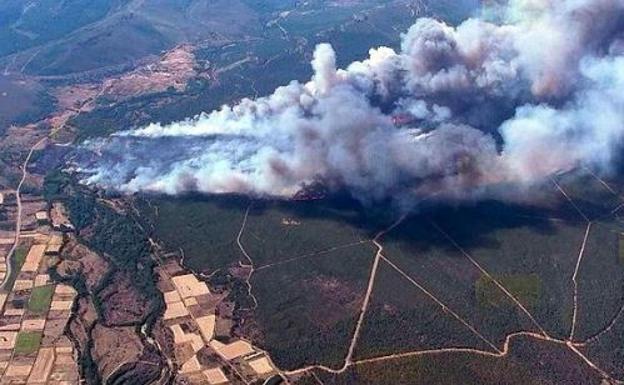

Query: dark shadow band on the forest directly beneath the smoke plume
<box><xmin>143</xmin><ymin>185</ymin><xmax>584</xmax><ymax>255</ymax></box>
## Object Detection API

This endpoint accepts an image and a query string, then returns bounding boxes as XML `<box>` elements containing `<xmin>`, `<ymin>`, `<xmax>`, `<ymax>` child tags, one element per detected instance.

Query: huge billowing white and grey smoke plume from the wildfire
<box><xmin>77</xmin><ymin>0</ymin><xmax>624</xmax><ymax>206</ymax></box>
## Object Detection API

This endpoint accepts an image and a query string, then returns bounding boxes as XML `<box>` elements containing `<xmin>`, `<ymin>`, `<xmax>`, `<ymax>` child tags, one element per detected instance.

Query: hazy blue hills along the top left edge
<box><xmin>0</xmin><ymin>0</ymin><xmax>474</xmax><ymax>75</ymax></box>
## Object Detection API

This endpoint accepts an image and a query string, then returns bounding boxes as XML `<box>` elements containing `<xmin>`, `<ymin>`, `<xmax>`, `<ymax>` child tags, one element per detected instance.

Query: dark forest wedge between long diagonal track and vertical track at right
<box><xmin>424</xmin><ymin>198</ymin><xmax>587</xmax><ymax>337</ymax></box>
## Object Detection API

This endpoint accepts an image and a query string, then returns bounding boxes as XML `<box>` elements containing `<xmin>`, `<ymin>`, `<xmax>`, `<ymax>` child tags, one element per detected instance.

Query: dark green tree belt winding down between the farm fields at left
<box><xmin>45</xmin><ymin>176</ymin><xmax>164</xmax><ymax>384</ymax></box>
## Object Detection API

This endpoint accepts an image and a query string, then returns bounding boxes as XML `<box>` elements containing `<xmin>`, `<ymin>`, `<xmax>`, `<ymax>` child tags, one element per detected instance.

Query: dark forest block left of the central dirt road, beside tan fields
<box><xmin>137</xmin><ymin>197</ymin><xmax>375</xmax><ymax>368</ymax></box>
